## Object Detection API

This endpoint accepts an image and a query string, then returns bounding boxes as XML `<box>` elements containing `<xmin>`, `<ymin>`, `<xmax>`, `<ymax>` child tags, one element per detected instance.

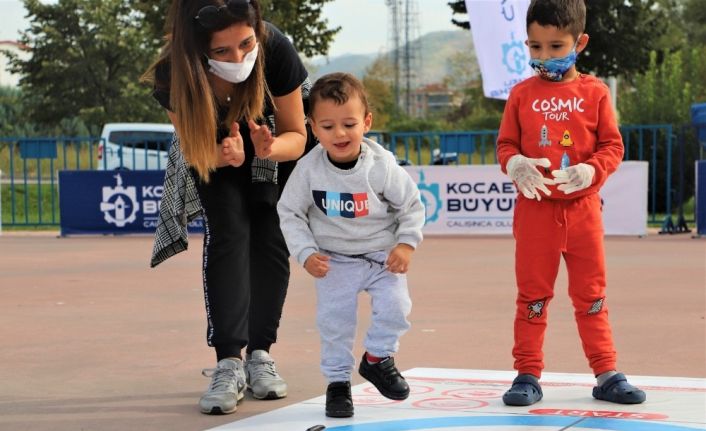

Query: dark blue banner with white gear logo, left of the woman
<box><xmin>59</xmin><ymin>171</ymin><xmax>203</xmax><ymax>235</ymax></box>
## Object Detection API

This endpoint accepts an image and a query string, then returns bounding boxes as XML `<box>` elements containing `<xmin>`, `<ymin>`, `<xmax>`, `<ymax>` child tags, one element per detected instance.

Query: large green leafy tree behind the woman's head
<box><xmin>11</xmin><ymin>0</ymin><xmax>339</xmax><ymax>130</ymax></box>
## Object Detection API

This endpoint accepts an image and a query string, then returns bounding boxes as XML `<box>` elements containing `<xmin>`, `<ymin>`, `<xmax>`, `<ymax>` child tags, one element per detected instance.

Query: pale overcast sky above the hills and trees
<box><xmin>0</xmin><ymin>0</ymin><xmax>458</xmax><ymax>57</ymax></box>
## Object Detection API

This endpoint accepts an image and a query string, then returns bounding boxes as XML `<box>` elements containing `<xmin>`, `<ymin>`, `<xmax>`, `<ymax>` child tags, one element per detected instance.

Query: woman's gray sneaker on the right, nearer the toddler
<box><xmin>245</xmin><ymin>350</ymin><xmax>287</xmax><ymax>400</ymax></box>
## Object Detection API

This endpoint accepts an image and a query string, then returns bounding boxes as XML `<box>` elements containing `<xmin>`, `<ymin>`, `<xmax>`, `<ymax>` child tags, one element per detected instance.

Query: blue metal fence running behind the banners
<box><xmin>0</xmin><ymin>124</ymin><xmax>688</xmax><ymax>227</ymax></box>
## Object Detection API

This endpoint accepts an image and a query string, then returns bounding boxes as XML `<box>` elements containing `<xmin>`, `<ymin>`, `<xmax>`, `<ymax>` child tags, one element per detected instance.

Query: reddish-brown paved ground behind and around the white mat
<box><xmin>0</xmin><ymin>231</ymin><xmax>706</xmax><ymax>431</ymax></box>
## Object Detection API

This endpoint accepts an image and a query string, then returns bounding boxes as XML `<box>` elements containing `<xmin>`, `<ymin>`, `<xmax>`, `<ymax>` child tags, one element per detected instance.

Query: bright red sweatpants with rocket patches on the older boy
<box><xmin>512</xmin><ymin>192</ymin><xmax>616</xmax><ymax>377</ymax></box>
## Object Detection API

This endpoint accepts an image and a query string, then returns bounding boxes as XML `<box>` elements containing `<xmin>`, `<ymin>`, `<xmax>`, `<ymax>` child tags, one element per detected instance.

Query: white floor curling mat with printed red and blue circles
<box><xmin>206</xmin><ymin>368</ymin><xmax>706</xmax><ymax>431</ymax></box>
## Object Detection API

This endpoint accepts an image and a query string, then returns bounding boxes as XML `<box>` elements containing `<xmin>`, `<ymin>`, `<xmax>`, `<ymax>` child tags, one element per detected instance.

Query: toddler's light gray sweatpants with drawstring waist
<box><xmin>316</xmin><ymin>251</ymin><xmax>412</xmax><ymax>383</ymax></box>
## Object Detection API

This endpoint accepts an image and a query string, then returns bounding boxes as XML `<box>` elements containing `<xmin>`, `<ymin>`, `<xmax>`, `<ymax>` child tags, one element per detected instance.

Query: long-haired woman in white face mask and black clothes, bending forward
<box><xmin>146</xmin><ymin>0</ymin><xmax>308</xmax><ymax>414</ymax></box>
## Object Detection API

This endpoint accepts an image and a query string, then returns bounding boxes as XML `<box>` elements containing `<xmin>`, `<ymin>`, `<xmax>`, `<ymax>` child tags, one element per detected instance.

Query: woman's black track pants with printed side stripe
<box><xmin>192</xmin><ymin>168</ymin><xmax>289</xmax><ymax>360</ymax></box>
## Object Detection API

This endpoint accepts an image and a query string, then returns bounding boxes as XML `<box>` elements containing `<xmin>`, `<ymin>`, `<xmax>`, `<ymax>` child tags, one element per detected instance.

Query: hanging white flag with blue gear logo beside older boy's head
<box><xmin>466</xmin><ymin>0</ymin><xmax>533</xmax><ymax>100</ymax></box>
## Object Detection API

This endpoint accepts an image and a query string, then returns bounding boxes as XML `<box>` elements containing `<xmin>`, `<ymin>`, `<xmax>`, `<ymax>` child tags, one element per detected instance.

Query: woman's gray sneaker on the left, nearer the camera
<box><xmin>199</xmin><ymin>358</ymin><xmax>245</xmax><ymax>415</ymax></box>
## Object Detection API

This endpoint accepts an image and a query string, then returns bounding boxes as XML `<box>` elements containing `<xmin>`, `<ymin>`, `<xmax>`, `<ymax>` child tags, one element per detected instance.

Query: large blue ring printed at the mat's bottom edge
<box><xmin>326</xmin><ymin>415</ymin><xmax>703</xmax><ymax>431</ymax></box>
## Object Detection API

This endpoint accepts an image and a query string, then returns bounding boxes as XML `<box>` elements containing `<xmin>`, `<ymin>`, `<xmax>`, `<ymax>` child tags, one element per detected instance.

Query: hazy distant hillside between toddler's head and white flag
<box><xmin>309</xmin><ymin>30</ymin><xmax>478</xmax><ymax>84</ymax></box>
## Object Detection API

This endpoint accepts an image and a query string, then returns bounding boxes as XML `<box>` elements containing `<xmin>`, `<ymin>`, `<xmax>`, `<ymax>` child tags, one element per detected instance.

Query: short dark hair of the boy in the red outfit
<box><xmin>527</xmin><ymin>0</ymin><xmax>586</xmax><ymax>39</ymax></box>
